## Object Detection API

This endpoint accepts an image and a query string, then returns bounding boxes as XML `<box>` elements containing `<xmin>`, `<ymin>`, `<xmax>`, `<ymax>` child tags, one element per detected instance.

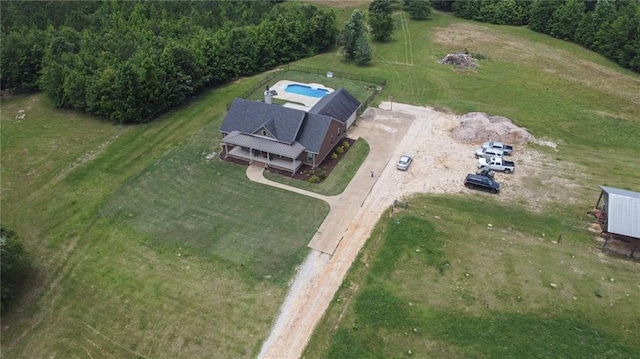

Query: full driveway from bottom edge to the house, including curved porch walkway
<box><xmin>247</xmin><ymin>104</ymin><xmax>414</xmax><ymax>359</ymax></box>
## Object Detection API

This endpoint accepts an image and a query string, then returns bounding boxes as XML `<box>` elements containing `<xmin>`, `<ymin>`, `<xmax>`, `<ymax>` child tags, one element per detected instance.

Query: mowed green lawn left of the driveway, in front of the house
<box><xmin>2</xmin><ymin>79</ymin><xmax>328</xmax><ymax>358</ymax></box>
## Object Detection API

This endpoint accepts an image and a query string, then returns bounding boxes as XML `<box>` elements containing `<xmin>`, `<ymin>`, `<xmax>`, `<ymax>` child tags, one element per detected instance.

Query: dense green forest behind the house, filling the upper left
<box><xmin>0</xmin><ymin>0</ymin><xmax>338</xmax><ymax>123</ymax></box>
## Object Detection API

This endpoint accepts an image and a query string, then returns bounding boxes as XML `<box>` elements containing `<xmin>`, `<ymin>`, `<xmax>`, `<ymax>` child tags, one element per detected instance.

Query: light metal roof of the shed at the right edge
<box><xmin>600</xmin><ymin>186</ymin><xmax>640</xmax><ymax>239</ymax></box>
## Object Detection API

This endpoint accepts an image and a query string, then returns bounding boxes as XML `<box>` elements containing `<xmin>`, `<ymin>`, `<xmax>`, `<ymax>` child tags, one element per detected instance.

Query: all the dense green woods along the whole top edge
<box><xmin>0</xmin><ymin>0</ymin><xmax>640</xmax><ymax>123</ymax></box>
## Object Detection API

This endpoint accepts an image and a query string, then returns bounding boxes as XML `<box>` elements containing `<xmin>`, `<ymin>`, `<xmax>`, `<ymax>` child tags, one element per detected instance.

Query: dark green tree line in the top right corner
<box><xmin>432</xmin><ymin>0</ymin><xmax>640</xmax><ymax>72</ymax></box>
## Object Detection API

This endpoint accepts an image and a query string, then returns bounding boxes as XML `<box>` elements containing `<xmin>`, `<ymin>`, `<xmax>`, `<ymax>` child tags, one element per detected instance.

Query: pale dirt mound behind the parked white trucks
<box><xmin>451</xmin><ymin>112</ymin><xmax>535</xmax><ymax>144</ymax></box>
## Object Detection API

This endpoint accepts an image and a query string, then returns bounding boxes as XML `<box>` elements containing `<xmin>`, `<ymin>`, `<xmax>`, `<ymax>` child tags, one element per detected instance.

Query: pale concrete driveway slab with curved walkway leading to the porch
<box><xmin>247</xmin><ymin>110</ymin><xmax>412</xmax><ymax>255</ymax></box>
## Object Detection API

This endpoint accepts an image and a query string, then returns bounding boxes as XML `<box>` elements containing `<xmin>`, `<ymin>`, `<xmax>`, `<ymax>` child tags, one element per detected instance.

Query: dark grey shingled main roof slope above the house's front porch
<box><xmin>220</xmin><ymin>98</ymin><xmax>306</xmax><ymax>144</ymax></box>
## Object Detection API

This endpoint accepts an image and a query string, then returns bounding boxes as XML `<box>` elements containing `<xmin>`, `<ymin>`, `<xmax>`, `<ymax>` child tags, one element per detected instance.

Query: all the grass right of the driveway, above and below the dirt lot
<box><xmin>305</xmin><ymin>8</ymin><xmax>640</xmax><ymax>358</ymax></box>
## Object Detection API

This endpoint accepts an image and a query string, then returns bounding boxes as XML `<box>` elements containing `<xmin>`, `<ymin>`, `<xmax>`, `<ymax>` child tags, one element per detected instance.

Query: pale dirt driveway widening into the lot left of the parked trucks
<box><xmin>258</xmin><ymin>102</ymin><xmax>540</xmax><ymax>359</ymax></box>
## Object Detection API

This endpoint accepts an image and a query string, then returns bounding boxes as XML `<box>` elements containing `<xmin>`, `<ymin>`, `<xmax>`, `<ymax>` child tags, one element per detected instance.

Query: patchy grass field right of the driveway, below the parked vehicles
<box><xmin>305</xmin><ymin>196</ymin><xmax>640</xmax><ymax>358</ymax></box>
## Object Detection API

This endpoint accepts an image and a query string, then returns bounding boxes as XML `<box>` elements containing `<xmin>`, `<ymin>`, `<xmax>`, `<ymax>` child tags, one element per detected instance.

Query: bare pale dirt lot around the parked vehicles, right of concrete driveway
<box><xmin>367</xmin><ymin>103</ymin><xmax>580</xmax><ymax>211</ymax></box>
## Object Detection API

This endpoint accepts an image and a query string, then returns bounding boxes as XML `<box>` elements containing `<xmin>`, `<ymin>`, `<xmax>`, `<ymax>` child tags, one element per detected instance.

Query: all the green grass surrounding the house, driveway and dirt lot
<box><xmin>0</xmin><ymin>3</ymin><xmax>640</xmax><ymax>358</ymax></box>
